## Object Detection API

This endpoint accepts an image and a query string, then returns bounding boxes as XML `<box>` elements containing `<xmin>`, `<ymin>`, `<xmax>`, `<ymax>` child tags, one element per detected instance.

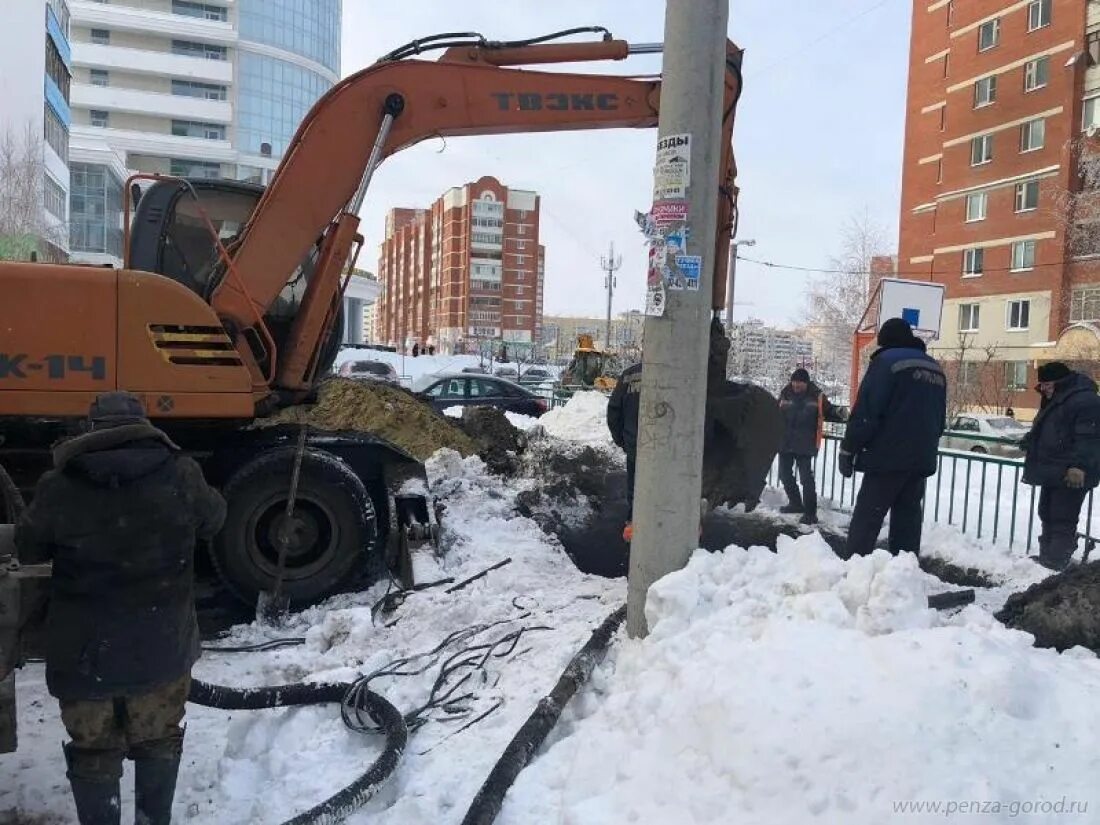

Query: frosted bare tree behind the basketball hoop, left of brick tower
<box><xmin>802</xmin><ymin>206</ymin><xmax>889</xmax><ymax>384</ymax></box>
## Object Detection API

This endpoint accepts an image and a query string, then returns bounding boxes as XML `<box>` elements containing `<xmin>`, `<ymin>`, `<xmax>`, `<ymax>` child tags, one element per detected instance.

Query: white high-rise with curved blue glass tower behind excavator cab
<box><xmin>68</xmin><ymin>0</ymin><xmax>341</xmax><ymax>263</ymax></box>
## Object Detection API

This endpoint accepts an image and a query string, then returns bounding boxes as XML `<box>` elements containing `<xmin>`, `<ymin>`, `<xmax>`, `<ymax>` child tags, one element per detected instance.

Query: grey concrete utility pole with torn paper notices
<box><xmin>627</xmin><ymin>0</ymin><xmax>729</xmax><ymax>637</ymax></box>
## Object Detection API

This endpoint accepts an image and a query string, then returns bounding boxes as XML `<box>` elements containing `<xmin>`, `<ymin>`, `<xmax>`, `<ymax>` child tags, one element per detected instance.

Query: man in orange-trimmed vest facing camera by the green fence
<box><xmin>779</xmin><ymin>367</ymin><xmax>840</xmax><ymax>525</ymax></box>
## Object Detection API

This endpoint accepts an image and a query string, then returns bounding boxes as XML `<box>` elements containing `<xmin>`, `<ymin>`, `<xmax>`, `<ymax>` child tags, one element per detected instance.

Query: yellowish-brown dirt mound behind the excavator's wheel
<box><xmin>256</xmin><ymin>378</ymin><xmax>481</xmax><ymax>461</ymax></box>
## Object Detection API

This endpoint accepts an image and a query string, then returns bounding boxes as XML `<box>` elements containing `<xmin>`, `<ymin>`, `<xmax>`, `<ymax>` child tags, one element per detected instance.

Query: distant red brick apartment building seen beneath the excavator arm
<box><xmin>376</xmin><ymin>177</ymin><xmax>545</xmax><ymax>353</ymax></box>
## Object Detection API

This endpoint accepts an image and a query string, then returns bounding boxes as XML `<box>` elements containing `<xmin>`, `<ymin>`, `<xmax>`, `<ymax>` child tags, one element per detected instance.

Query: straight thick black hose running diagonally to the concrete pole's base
<box><xmin>462</xmin><ymin>605</ymin><xmax>626</xmax><ymax>825</ymax></box>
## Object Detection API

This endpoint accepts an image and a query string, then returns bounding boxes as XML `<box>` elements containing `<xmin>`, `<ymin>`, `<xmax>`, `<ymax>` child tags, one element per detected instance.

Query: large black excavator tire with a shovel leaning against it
<box><xmin>211</xmin><ymin>449</ymin><xmax>378</xmax><ymax>605</ymax></box>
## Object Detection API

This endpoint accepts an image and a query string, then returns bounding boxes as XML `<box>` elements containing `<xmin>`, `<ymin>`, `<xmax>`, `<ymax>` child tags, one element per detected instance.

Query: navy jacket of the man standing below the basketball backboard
<box><xmin>840</xmin><ymin>347</ymin><xmax>947</xmax><ymax>475</ymax></box>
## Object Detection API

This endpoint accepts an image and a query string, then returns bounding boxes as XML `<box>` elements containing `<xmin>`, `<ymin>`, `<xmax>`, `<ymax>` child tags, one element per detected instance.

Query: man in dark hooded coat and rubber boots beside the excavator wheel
<box><xmin>15</xmin><ymin>393</ymin><xmax>226</xmax><ymax>825</ymax></box>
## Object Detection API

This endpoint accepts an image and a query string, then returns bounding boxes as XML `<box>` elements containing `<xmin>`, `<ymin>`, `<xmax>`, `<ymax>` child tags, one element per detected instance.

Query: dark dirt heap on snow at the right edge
<box><xmin>997</xmin><ymin>561</ymin><xmax>1100</xmax><ymax>653</ymax></box>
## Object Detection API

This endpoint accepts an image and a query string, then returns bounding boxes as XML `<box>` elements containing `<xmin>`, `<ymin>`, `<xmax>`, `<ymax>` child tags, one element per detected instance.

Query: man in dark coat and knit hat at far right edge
<box><xmin>1022</xmin><ymin>361</ymin><xmax>1100</xmax><ymax>570</ymax></box>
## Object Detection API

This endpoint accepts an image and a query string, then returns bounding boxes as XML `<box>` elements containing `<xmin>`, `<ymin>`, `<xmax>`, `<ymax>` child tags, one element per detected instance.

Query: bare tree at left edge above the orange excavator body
<box><xmin>0</xmin><ymin>123</ymin><xmax>66</xmax><ymax>260</ymax></box>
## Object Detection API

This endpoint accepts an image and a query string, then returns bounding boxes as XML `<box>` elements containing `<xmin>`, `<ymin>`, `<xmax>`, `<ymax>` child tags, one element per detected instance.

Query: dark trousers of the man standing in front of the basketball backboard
<box><xmin>847</xmin><ymin>473</ymin><xmax>926</xmax><ymax>556</ymax></box>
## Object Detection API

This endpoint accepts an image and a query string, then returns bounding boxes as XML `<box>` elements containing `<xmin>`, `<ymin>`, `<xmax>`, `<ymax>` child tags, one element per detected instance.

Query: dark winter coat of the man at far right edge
<box><xmin>1023</xmin><ymin>372</ymin><xmax>1100</xmax><ymax>487</ymax></box>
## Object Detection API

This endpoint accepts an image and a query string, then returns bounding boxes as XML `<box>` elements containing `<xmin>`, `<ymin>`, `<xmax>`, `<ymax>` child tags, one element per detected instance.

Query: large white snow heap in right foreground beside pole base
<box><xmin>498</xmin><ymin>536</ymin><xmax>1100</xmax><ymax>825</ymax></box>
